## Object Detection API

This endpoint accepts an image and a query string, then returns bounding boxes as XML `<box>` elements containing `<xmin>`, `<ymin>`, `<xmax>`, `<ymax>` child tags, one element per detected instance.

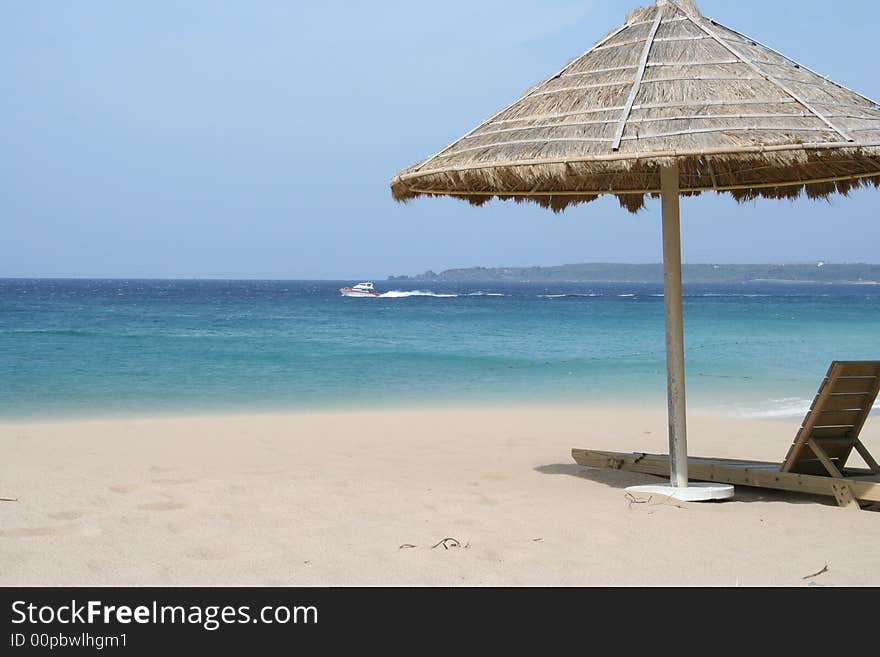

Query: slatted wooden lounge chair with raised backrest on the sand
<box><xmin>572</xmin><ymin>361</ymin><xmax>880</xmax><ymax>509</ymax></box>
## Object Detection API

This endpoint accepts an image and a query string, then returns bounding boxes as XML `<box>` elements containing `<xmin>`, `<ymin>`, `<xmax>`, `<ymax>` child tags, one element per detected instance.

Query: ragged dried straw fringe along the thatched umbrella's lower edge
<box><xmin>392</xmin><ymin>148</ymin><xmax>880</xmax><ymax>212</ymax></box>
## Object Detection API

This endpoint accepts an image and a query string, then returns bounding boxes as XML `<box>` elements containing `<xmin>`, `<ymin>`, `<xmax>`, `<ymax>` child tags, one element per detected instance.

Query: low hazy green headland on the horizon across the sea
<box><xmin>388</xmin><ymin>262</ymin><xmax>880</xmax><ymax>284</ymax></box>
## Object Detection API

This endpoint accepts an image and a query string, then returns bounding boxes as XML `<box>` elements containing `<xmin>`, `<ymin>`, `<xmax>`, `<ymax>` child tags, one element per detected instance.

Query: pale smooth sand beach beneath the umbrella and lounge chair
<box><xmin>0</xmin><ymin>407</ymin><xmax>880</xmax><ymax>586</ymax></box>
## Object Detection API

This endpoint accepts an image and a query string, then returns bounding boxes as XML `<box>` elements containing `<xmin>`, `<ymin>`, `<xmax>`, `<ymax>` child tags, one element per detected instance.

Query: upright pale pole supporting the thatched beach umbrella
<box><xmin>660</xmin><ymin>163</ymin><xmax>688</xmax><ymax>488</ymax></box>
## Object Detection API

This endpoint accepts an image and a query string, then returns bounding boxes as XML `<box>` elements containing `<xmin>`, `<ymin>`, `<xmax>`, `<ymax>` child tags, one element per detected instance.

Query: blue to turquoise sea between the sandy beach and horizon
<box><xmin>0</xmin><ymin>279</ymin><xmax>880</xmax><ymax>419</ymax></box>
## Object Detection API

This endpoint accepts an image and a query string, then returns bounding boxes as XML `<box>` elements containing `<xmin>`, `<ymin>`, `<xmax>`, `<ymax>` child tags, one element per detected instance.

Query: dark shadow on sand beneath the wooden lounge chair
<box><xmin>535</xmin><ymin>463</ymin><xmax>860</xmax><ymax>511</ymax></box>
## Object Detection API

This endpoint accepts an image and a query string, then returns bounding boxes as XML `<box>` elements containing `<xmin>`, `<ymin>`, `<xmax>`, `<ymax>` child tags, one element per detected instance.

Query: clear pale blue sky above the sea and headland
<box><xmin>0</xmin><ymin>0</ymin><xmax>880</xmax><ymax>279</ymax></box>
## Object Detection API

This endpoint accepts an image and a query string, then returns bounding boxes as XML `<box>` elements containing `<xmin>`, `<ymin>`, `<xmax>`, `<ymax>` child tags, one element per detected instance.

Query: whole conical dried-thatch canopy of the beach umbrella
<box><xmin>391</xmin><ymin>0</ymin><xmax>880</xmax><ymax>212</ymax></box>
